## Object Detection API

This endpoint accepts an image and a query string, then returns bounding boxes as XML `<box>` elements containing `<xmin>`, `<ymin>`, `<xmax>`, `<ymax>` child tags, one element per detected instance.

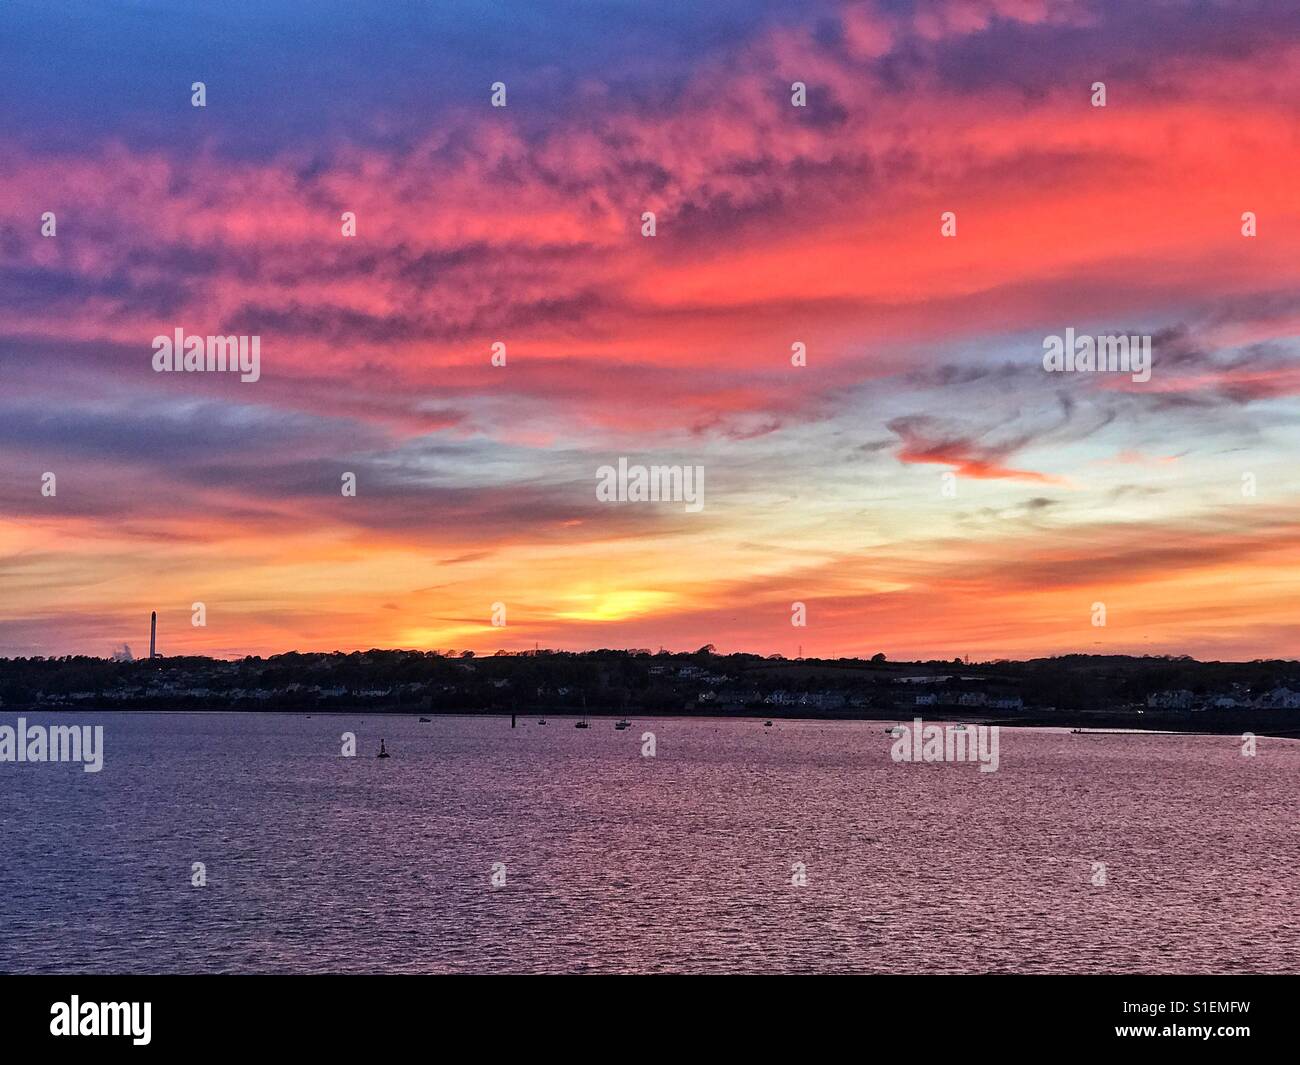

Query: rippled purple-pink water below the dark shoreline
<box><xmin>0</xmin><ymin>714</ymin><xmax>1300</xmax><ymax>973</ymax></box>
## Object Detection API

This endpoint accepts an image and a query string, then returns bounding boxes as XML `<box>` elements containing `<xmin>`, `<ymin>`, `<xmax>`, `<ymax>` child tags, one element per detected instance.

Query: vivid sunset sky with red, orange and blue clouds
<box><xmin>0</xmin><ymin>0</ymin><xmax>1300</xmax><ymax>659</ymax></box>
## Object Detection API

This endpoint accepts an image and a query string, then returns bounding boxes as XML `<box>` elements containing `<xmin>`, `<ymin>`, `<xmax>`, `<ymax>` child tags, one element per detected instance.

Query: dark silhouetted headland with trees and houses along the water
<box><xmin>0</xmin><ymin>648</ymin><xmax>1300</xmax><ymax>737</ymax></box>
